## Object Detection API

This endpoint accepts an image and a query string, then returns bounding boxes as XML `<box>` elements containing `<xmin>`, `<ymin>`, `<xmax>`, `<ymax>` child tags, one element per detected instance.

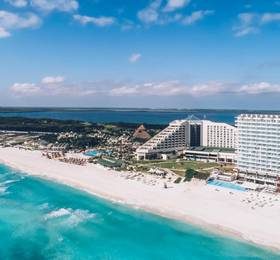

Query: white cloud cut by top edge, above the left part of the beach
<box><xmin>31</xmin><ymin>0</ymin><xmax>79</xmax><ymax>12</ymax></box>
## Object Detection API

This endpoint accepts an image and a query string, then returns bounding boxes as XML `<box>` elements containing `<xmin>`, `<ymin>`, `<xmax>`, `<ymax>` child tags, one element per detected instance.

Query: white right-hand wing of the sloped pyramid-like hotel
<box><xmin>201</xmin><ymin>120</ymin><xmax>237</xmax><ymax>148</ymax></box>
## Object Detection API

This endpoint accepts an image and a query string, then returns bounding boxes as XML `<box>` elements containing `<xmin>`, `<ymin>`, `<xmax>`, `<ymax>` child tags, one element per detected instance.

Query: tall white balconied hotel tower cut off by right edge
<box><xmin>236</xmin><ymin>114</ymin><xmax>280</xmax><ymax>185</ymax></box>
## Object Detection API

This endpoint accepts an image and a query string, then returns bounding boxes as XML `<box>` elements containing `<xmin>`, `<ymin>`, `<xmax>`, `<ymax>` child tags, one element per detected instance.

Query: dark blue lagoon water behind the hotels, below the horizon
<box><xmin>0</xmin><ymin>110</ymin><xmax>240</xmax><ymax>124</ymax></box>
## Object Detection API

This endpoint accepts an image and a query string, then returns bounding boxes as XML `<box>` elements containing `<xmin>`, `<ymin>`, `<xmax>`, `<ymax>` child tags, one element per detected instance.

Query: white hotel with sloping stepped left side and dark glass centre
<box><xmin>136</xmin><ymin>117</ymin><xmax>236</xmax><ymax>160</ymax></box>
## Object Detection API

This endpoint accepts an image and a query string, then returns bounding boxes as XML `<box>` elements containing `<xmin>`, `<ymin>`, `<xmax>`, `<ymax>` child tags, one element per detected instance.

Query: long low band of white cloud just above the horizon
<box><xmin>9</xmin><ymin>76</ymin><xmax>280</xmax><ymax>98</ymax></box>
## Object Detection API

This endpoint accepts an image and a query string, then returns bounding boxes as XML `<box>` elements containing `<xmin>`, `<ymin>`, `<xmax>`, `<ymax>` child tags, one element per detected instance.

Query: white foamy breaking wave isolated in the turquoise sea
<box><xmin>45</xmin><ymin>208</ymin><xmax>95</xmax><ymax>227</ymax></box>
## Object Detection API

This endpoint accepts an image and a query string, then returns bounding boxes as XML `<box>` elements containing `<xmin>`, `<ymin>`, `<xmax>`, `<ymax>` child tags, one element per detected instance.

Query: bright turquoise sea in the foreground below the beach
<box><xmin>0</xmin><ymin>164</ymin><xmax>280</xmax><ymax>260</ymax></box>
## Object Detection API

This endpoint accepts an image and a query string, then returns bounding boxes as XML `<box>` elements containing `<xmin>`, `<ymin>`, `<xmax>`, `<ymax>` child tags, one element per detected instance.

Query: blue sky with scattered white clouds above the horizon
<box><xmin>0</xmin><ymin>0</ymin><xmax>280</xmax><ymax>109</ymax></box>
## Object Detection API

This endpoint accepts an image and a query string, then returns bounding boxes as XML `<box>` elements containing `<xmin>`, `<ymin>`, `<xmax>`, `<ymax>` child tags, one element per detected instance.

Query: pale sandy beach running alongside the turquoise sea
<box><xmin>0</xmin><ymin>148</ymin><xmax>280</xmax><ymax>250</ymax></box>
